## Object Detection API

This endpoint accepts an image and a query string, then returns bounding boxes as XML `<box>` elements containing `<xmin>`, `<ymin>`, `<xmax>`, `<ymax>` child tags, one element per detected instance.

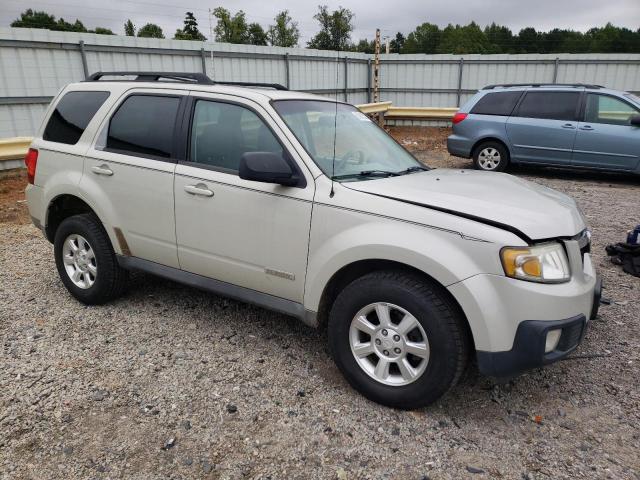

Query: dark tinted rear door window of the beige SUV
<box><xmin>106</xmin><ymin>95</ymin><xmax>180</xmax><ymax>158</ymax></box>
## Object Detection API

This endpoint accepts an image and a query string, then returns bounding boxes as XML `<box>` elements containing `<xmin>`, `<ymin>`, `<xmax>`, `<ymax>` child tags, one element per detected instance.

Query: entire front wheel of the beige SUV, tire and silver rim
<box><xmin>328</xmin><ymin>271</ymin><xmax>468</xmax><ymax>409</ymax></box>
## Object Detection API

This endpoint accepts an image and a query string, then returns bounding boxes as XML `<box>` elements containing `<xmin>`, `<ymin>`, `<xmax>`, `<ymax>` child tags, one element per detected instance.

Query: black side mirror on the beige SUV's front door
<box><xmin>238</xmin><ymin>152</ymin><xmax>298</xmax><ymax>187</ymax></box>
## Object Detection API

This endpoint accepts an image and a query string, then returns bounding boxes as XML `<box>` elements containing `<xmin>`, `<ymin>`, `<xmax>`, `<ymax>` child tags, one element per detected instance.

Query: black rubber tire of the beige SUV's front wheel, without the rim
<box><xmin>328</xmin><ymin>271</ymin><xmax>469</xmax><ymax>409</ymax></box>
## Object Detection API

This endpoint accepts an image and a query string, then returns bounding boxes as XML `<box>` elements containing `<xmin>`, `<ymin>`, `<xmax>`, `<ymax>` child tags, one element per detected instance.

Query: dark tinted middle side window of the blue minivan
<box><xmin>517</xmin><ymin>91</ymin><xmax>580</xmax><ymax>120</ymax></box>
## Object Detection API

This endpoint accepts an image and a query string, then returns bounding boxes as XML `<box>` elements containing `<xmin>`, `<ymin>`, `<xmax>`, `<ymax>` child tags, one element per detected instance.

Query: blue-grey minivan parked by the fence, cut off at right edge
<box><xmin>447</xmin><ymin>84</ymin><xmax>640</xmax><ymax>174</ymax></box>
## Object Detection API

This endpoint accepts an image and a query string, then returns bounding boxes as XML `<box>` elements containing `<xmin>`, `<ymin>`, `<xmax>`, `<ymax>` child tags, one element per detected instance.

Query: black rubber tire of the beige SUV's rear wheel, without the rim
<box><xmin>53</xmin><ymin>213</ymin><xmax>129</xmax><ymax>305</ymax></box>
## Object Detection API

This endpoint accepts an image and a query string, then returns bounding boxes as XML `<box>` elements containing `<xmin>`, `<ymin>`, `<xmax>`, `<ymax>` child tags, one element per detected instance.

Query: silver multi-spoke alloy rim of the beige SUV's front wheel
<box><xmin>349</xmin><ymin>302</ymin><xmax>430</xmax><ymax>386</ymax></box>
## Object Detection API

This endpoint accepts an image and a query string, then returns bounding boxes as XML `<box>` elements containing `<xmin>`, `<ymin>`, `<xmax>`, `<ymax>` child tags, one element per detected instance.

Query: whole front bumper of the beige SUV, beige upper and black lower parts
<box><xmin>448</xmin><ymin>240</ymin><xmax>601</xmax><ymax>376</ymax></box>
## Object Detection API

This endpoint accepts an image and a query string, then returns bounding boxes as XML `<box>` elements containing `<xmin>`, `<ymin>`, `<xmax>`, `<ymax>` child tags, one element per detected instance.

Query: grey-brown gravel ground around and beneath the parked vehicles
<box><xmin>0</xmin><ymin>129</ymin><xmax>640</xmax><ymax>480</ymax></box>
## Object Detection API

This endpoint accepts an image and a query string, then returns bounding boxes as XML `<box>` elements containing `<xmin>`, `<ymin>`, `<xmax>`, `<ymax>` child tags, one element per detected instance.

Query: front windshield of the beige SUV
<box><xmin>273</xmin><ymin>100</ymin><xmax>427</xmax><ymax>181</ymax></box>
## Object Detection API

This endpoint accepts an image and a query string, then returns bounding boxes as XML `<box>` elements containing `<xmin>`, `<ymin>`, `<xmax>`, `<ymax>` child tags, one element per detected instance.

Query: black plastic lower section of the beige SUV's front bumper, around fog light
<box><xmin>477</xmin><ymin>315</ymin><xmax>588</xmax><ymax>377</ymax></box>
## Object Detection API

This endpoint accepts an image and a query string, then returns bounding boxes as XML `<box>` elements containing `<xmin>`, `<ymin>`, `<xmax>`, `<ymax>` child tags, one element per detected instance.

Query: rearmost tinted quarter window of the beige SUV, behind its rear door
<box><xmin>42</xmin><ymin>91</ymin><xmax>109</xmax><ymax>145</ymax></box>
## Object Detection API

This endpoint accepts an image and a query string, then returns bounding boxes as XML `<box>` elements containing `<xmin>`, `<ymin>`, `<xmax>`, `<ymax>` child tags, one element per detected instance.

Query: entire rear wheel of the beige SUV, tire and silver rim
<box><xmin>53</xmin><ymin>214</ymin><xmax>128</xmax><ymax>305</ymax></box>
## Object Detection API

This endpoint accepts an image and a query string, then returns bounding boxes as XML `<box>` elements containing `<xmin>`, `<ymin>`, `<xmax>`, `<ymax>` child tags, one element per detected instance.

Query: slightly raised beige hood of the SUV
<box><xmin>343</xmin><ymin>169</ymin><xmax>586</xmax><ymax>240</ymax></box>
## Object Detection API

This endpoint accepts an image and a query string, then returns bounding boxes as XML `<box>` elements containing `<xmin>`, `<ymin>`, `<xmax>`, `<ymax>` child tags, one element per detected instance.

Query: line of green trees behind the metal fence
<box><xmin>11</xmin><ymin>5</ymin><xmax>640</xmax><ymax>54</ymax></box>
